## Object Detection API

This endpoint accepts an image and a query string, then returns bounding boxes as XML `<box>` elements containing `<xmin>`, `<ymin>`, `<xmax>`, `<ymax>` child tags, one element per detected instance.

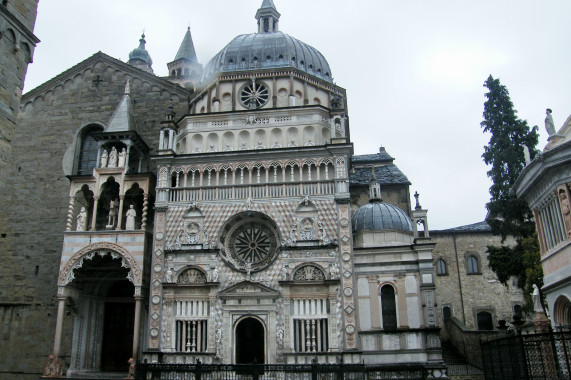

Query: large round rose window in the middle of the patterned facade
<box><xmin>221</xmin><ymin>213</ymin><xmax>279</xmax><ymax>272</ymax></box>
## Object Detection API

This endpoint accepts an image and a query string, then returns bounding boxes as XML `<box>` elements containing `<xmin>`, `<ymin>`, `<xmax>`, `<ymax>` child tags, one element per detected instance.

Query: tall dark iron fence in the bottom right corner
<box><xmin>481</xmin><ymin>331</ymin><xmax>571</xmax><ymax>380</ymax></box>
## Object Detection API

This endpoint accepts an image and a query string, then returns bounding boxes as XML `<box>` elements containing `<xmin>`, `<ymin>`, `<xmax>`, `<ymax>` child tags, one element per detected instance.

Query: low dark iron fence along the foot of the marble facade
<box><xmin>135</xmin><ymin>363</ymin><xmax>434</xmax><ymax>380</ymax></box>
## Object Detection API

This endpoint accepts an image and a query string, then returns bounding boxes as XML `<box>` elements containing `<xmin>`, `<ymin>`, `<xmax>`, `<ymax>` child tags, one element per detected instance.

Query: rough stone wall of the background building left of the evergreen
<box><xmin>430</xmin><ymin>231</ymin><xmax>524</xmax><ymax>332</ymax></box>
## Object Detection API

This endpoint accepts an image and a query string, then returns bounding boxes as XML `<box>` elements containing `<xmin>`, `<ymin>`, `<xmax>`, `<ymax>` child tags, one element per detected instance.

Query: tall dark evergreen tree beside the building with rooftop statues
<box><xmin>481</xmin><ymin>75</ymin><xmax>543</xmax><ymax>308</ymax></box>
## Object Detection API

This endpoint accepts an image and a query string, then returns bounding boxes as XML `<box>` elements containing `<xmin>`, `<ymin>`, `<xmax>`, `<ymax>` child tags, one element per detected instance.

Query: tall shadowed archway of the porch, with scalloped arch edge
<box><xmin>69</xmin><ymin>251</ymin><xmax>135</xmax><ymax>375</ymax></box>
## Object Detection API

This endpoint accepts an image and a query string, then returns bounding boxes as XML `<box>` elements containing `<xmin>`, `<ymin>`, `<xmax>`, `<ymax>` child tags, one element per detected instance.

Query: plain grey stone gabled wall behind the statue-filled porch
<box><xmin>0</xmin><ymin>53</ymin><xmax>190</xmax><ymax>379</ymax></box>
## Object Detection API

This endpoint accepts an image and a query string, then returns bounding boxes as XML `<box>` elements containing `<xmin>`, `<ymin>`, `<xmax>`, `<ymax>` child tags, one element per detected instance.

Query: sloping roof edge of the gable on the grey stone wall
<box><xmin>21</xmin><ymin>51</ymin><xmax>191</xmax><ymax>105</ymax></box>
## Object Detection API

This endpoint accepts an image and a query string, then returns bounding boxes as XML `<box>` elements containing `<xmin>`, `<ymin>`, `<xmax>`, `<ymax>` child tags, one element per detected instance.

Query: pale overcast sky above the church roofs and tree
<box><xmin>24</xmin><ymin>0</ymin><xmax>571</xmax><ymax>229</ymax></box>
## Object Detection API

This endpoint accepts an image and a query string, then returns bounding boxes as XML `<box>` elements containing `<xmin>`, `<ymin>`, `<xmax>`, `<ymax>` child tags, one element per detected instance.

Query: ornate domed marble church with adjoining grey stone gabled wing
<box><xmin>5</xmin><ymin>0</ymin><xmax>452</xmax><ymax>377</ymax></box>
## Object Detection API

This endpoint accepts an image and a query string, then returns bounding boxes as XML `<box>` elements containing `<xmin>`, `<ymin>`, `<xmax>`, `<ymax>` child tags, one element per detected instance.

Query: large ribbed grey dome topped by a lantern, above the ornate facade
<box><xmin>202</xmin><ymin>31</ymin><xmax>333</xmax><ymax>82</ymax></box>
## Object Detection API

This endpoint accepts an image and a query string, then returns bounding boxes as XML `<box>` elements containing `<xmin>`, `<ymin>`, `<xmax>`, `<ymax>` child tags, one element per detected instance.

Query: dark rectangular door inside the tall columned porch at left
<box><xmin>101</xmin><ymin>302</ymin><xmax>135</xmax><ymax>372</ymax></box>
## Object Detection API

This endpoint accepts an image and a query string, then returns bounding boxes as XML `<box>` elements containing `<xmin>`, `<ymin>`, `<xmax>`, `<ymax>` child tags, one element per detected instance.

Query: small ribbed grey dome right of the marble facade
<box><xmin>351</xmin><ymin>202</ymin><xmax>413</xmax><ymax>232</ymax></box>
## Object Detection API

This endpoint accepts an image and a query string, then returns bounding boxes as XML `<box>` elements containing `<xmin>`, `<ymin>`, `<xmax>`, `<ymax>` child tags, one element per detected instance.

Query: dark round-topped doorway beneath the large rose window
<box><xmin>236</xmin><ymin>318</ymin><xmax>266</xmax><ymax>364</ymax></box>
